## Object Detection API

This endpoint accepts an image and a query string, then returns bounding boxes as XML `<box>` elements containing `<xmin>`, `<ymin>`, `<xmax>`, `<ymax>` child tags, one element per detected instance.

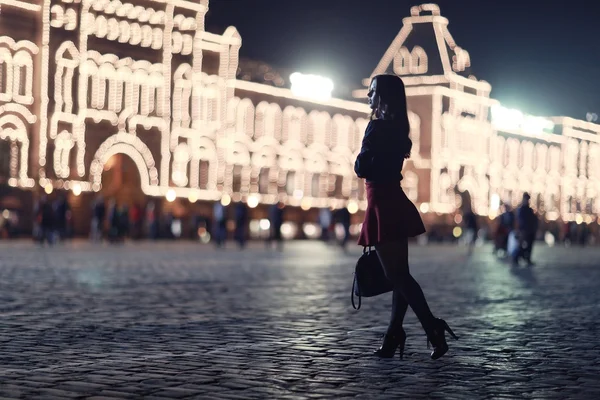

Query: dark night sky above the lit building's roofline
<box><xmin>206</xmin><ymin>0</ymin><xmax>600</xmax><ymax>119</ymax></box>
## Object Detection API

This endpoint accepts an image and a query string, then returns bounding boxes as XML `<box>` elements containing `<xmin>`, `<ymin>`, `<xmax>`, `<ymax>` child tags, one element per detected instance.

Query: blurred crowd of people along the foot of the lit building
<box><xmin>0</xmin><ymin>194</ymin><xmax>600</xmax><ymax>253</ymax></box>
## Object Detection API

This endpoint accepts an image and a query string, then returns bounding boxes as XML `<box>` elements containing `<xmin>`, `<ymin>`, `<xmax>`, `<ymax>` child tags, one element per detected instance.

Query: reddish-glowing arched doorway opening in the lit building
<box><xmin>100</xmin><ymin>153</ymin><xmax>146</xmax><ymax>207</ymax></box>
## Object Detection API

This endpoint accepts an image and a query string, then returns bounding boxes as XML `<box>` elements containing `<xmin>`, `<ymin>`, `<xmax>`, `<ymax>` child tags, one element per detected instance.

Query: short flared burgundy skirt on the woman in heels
<box><xmin>358</xmin><ymin>182</ymin><xmax>425</xmax><ymax>246</ymax></box>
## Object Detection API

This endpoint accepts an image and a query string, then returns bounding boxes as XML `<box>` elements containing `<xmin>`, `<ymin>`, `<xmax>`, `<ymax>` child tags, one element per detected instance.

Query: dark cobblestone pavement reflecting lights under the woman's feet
<box><xmin>0</xmin><ymin>242</ymin><xmax>600</xmax><ymax>399</ymax></box>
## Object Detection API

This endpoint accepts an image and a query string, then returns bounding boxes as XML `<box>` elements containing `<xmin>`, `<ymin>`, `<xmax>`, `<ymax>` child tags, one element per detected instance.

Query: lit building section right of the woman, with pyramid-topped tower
<box><xmin>355</xmin><ymin>4</ymin><xmax>600</xmax><ymax>228</ymax></box>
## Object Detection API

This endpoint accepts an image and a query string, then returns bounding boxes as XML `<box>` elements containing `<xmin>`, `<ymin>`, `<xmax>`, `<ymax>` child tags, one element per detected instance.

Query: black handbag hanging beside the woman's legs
<box><xmin>351</xmin><ymin>247</ymin><xmax>394</xmax><ymax>310</ymax></box>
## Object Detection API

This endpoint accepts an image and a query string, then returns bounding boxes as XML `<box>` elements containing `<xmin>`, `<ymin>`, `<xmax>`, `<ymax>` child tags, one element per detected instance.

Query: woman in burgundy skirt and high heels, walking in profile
<box><xmin>354</xmin><ymin>75</ymin><xmax>456</xmax><ymax>360</ymax></box>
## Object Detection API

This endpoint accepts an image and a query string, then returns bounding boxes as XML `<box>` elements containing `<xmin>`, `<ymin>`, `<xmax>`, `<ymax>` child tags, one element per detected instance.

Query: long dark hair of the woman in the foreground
<box><xmin>373</xmin><ymin>75</ymin><xmax>412</xmax><ymax>158</ymax></box>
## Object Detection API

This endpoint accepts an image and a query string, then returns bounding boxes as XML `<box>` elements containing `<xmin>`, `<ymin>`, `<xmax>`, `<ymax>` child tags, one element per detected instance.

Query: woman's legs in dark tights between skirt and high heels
<box><xmin>375</xmin><ymin>238</ymin><xmax>434</xmax><ymax>334</ymax></box>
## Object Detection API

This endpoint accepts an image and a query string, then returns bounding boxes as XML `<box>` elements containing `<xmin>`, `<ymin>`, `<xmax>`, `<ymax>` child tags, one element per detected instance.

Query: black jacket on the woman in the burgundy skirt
<box><xmin>354</xmin><ymin>120</ymin><xmax>408</xmax><ymax>183</ymax></box>
